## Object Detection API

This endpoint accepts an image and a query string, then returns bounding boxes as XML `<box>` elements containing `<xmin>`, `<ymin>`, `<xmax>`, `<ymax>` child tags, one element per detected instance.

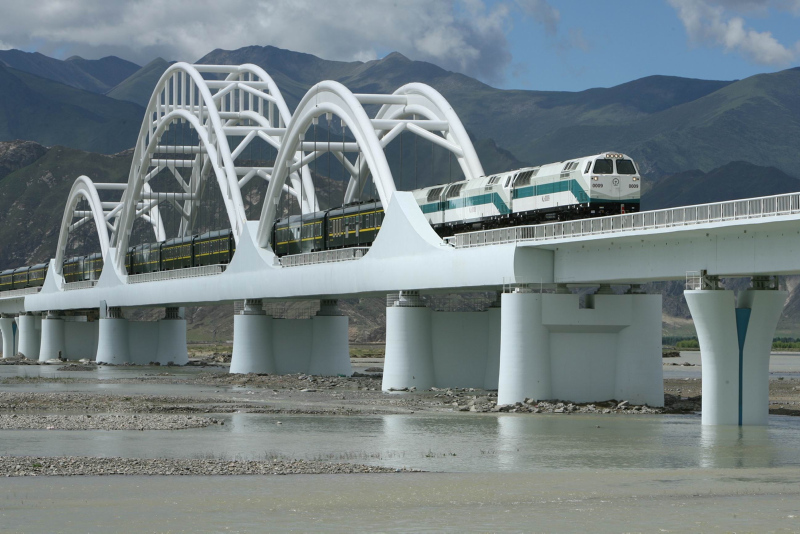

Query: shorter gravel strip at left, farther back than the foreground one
<box><xmin>0</xmin><ymin>413</ymin><xmax>225</xmax><ymax>430</ymax></box>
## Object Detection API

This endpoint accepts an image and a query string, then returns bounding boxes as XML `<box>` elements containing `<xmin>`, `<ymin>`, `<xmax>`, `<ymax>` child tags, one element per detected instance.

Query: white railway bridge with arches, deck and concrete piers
<box><xmin>0</xmin><ymin>63</ymin><xmax>800</xmax><ymax>425</ymax></box>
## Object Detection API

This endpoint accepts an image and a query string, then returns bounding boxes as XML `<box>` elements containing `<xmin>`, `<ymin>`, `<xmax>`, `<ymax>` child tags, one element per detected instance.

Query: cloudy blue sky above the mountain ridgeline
<box><xmin>0</xmin><ymin>0</ymin><xmax>800</xmax><ymax>91</ymax></box>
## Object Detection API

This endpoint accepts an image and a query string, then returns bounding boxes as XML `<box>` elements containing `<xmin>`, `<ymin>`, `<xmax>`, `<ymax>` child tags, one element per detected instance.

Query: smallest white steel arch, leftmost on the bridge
<box><xmin>55</xmin><ymin>176</ymin><xmax>113</xmax><ymax>275</ymax></box>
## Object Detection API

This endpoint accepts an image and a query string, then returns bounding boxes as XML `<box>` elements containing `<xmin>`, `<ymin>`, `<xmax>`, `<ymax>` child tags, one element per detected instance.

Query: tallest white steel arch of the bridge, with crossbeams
<box><xmin>111</xmin><ymin>63</ymin><xmax>304</xmax><ymax>272</ymax></box>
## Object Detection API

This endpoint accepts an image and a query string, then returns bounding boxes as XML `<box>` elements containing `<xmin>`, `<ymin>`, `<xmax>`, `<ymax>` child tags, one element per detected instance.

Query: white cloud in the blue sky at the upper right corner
<box><xmin>669</xmin><ymin>0</ymin><xmax>800</xmax><ymax>65</ymax></box>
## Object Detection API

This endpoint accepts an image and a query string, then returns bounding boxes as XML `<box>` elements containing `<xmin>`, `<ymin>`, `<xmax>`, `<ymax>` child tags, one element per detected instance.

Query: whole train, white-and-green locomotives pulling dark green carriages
<box><xmin>0</xmin><ymin>152</ymin><xmax>642</xmax><ymax>291</ymax></box>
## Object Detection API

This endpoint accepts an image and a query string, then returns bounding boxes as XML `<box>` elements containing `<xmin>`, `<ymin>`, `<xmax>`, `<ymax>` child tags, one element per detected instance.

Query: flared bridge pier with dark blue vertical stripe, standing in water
<box><xmin>684</xmin><ymin>280</ymin><xmax>787</xmax><ymax>426</ymax></box>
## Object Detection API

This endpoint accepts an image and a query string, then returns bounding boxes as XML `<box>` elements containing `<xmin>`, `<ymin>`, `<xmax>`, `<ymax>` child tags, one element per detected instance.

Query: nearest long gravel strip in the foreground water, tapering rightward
<box><xmin>0</xmin><ymin>456</ymin><xmax>408</xmax><ymax>477</ymax></box>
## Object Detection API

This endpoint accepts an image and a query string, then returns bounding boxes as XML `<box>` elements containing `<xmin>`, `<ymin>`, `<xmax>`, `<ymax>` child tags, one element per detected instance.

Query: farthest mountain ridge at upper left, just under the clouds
<box><xmin>0</xmin><ymin>50</ymin><xmax>139</xmax><ymax>94</ymax></box>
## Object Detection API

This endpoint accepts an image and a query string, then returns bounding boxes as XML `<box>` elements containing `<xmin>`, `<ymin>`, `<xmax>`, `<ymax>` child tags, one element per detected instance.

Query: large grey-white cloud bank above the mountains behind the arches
<box><xmin>0</xmin><ymin>0</ymin><xmax>560</xmax><ymax>85</ymax></box>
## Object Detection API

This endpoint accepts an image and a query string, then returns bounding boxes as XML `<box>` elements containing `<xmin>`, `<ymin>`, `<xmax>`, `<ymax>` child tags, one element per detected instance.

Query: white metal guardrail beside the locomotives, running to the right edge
<box><xmin>445</xmin><ymin>193</ymin><xmax>800</xmax><ymax>248</ymax></box>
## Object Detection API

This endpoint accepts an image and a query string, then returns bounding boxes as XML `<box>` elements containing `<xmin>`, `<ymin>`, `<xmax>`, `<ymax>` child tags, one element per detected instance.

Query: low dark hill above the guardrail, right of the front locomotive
<box><xmin>642</xmin><ymin>161</ymin><xmax>800</xmax><ymax>210</ymax></box>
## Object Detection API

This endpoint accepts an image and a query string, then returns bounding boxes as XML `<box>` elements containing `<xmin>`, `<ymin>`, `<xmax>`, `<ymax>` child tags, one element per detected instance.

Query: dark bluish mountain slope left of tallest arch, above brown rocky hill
<box><xmin>0</xmin><ymin>66</ymin><xmax>144</xmax><ymax>153</ymax></box>
